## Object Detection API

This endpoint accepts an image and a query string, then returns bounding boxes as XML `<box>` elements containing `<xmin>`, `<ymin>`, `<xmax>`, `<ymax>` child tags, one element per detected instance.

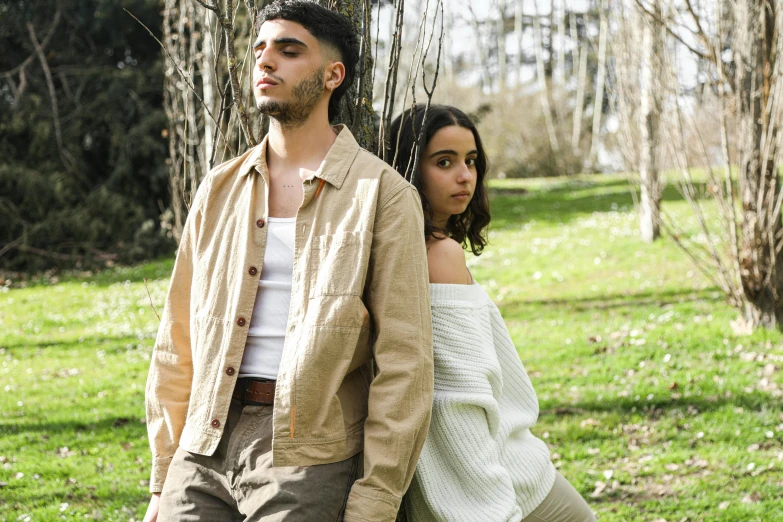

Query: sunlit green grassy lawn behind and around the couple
<box><xmin>0</xmin><ymin>176</ymin><xmax>783</xmax><ymax>522</ymax></box>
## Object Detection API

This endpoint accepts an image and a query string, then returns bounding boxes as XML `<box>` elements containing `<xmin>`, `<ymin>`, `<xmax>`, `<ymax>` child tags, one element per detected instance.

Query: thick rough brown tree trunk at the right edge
<box><xmin>734</xmin><ymin>0</ymin><xmax>783</xmax><ymax>328</ymax></box>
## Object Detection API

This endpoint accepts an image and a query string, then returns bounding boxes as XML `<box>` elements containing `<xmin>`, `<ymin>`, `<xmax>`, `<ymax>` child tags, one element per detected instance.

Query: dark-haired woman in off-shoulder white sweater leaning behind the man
<box><xmin>387</xmin><ymin>105</ymin><xmax>596</xmax><ymax>522</ymax></box>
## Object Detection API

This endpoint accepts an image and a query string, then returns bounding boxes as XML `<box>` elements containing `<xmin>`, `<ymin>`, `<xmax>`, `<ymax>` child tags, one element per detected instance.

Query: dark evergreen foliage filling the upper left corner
<box><xmin>0</xmin><ymin>0</ymin><xmax>173</xmax><ymax>271</ymax></box>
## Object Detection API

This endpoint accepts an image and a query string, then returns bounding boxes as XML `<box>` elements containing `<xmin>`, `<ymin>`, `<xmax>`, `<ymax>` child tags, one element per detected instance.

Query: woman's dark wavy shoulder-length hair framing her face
<box><xmin>385</xmin><ymin>104</ymin><xmax>490</xmax><ymax>256</ymax></box>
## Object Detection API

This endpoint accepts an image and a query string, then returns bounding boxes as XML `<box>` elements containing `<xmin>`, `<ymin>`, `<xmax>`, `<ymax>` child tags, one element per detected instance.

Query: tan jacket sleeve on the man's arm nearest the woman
<box><xmin>345</xmin><ymin>186</ymin><xmax>433</xmax><ymax>522</ymax></box>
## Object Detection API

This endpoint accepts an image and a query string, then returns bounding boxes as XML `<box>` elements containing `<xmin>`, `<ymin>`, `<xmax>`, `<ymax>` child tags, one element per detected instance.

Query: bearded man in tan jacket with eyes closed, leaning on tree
<box><xmin>145</xmin><ymin>0</ymin><xmax>433</xmax><ymax>522</ymax></box>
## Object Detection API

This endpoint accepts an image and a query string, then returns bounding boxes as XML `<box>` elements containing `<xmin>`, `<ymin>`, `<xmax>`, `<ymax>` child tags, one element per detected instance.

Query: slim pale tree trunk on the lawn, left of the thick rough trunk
<box><xmin>639</xmin><ymin>0</ymin><xmax>665</xmax><ymax>243</ymax></box>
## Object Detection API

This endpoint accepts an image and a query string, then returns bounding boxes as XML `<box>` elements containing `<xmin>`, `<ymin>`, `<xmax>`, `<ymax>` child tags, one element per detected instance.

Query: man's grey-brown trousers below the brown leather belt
<box><xmin>158</xmin><ymin>399</ymin><xmax>362</xmax><ymax>522</ymax></box>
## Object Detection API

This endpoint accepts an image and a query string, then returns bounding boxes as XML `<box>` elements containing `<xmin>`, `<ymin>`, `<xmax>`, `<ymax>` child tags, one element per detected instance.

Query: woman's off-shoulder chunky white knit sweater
<box><xmin>406</xmin><ymin>284</ymin><xmax>556</xmax><ymax>522</ymax></box>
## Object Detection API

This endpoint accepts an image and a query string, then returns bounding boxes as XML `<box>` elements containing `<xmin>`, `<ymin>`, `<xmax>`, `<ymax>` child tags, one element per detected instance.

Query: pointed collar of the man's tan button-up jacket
<box><xmin>239</xmin><ymin>124</ymin><xmax>360</xmax><ymax>189</ymax></box>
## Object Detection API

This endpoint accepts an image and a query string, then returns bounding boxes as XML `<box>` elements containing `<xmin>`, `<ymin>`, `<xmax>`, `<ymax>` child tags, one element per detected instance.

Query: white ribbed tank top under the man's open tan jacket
<box><xmin>239</xmin><ymin>217</ymin><xmax>296</xmax><ymax>379</ymax></box>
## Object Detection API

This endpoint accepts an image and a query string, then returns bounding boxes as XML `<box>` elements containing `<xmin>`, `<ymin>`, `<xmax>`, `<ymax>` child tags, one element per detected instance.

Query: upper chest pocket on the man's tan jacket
<box><xmin>310</xmin><ymin>232</ymin><xmax>372</xmax><ymax>298</ymax></box>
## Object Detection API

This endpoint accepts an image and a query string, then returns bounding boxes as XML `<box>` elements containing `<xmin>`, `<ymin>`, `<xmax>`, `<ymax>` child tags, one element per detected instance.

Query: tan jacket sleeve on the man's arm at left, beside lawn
<box><xmin>146</xmin><ymin>178</ymin><xmax>209</xmax><ymax>493</ymax></box>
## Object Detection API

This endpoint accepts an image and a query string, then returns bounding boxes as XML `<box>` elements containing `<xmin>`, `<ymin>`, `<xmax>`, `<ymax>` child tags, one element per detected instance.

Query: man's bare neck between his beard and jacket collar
<box><xmin>266</xmin><ymin>118</ymin><xmax>337</xmax><ymax>179</ymax></box>
